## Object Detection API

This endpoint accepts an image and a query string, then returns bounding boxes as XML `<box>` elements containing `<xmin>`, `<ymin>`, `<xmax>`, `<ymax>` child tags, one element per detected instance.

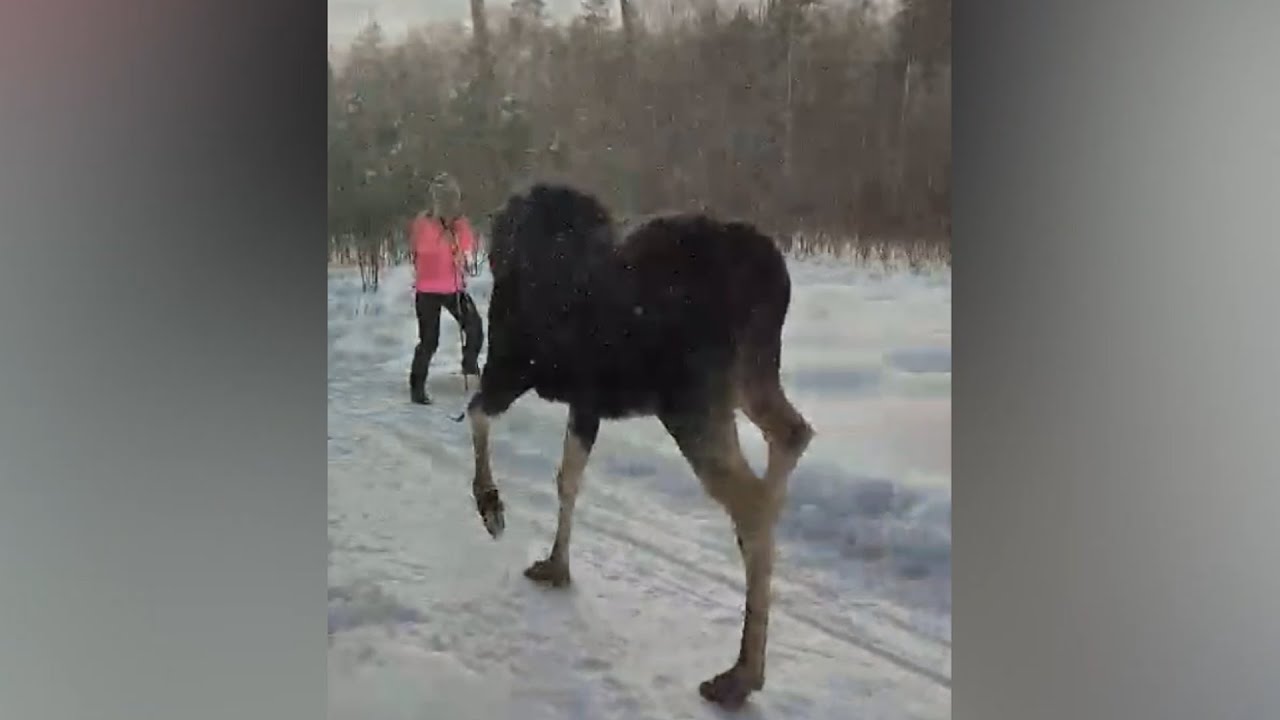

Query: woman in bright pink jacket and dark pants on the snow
<box><xmin>408</xmin><ymin>173</ymin><xmax>484</xmax><ymax>405</ymax></box>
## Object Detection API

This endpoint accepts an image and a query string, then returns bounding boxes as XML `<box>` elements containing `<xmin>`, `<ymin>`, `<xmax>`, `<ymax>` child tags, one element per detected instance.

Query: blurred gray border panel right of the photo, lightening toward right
<box><xmin>962</xmin><ymin>0</ymin><xmax>1280</xmax><ymax>720</ymax></box>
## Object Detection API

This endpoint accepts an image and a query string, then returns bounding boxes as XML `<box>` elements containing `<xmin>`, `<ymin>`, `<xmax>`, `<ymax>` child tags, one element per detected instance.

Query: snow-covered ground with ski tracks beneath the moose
<box><xmin>329</xmin><ymin>261</ymin><xmax>951</xmax><ymax>720</ymax></box>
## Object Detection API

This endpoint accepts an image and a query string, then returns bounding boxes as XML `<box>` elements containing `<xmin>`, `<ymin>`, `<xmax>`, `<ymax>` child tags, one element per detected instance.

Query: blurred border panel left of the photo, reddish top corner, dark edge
<box><xmin>0</xmin><ymin>0</ymin><xmax>326</xmax><ymax>720</ymax></box>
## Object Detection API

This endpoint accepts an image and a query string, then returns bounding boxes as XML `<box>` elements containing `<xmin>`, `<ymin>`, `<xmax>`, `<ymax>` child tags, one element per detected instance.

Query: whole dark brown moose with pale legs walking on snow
<box><xmin>467</xmin><ymin>184</ymin><xmax>813</xmax><ymax>707</ymax></box>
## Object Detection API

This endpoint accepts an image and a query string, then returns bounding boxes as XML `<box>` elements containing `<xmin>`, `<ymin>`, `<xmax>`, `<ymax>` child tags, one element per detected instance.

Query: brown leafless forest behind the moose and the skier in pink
<box><xmin>328</xmin><ymin>0</ymin><xmax>951</xmax><ymax>280</ymax></box>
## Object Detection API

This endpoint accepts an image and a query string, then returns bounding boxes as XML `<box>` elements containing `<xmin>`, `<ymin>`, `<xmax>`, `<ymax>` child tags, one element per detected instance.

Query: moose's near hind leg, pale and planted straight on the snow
<box><xmin>663</xmin><ymin>410</ymin><xmax>777</xmax><ymax>708</ymax></box>
